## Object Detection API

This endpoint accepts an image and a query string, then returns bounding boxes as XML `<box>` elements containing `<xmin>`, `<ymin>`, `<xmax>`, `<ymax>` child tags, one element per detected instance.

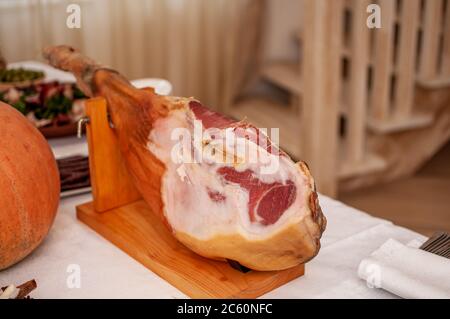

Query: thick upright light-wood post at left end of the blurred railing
<box><xmin>299</xmin><ymin>0</ymin><xmax>343</xmax><ymax>196</ymax></box>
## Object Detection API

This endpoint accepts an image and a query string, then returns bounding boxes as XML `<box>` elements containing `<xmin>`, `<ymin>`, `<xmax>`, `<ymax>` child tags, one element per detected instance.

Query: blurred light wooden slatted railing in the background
<box><xmin>228</xmin><ymin>0</ymin><xmax>450</xmax><ymax>196</ymax></box>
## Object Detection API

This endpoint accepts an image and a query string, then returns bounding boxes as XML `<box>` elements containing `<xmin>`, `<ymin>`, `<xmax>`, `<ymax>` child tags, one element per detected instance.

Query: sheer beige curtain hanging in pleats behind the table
<box><xmin>0</xmin><ymin>0</ymin><xmax>264</xmax><ymax>108</ymax></box>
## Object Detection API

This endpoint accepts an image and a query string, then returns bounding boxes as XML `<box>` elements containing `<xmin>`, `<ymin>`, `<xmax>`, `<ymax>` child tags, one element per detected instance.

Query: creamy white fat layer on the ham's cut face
<box><xmin>147</xmin><ymin>104</ymin><xmax>308</xmax><ymax>240</ymax></box>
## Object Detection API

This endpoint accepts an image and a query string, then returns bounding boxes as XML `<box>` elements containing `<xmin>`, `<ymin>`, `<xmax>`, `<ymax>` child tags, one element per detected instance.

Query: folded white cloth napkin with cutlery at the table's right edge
<box><xmin>358</xmin><ymin>239</ymin><xmax>450</xmax><ymax>298</ymax></box>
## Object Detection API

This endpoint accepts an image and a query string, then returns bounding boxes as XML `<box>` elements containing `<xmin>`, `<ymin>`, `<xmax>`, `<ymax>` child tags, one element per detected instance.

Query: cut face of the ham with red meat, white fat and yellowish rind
<box><xmin>147</xmin><ymin>98</ymin><xmax>325</xmax><ymax>270</ymax></box>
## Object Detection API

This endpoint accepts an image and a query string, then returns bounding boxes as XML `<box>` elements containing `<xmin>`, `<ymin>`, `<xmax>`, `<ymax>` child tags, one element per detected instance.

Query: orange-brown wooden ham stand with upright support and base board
<box><xmin>76</xmin><ymin>98</ymin><xmax>304</xmax><ymax>298</ymax></box>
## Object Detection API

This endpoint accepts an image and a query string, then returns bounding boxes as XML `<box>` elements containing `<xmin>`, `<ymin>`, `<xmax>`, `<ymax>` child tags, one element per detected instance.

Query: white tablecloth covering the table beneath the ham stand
<box><xmin>0</xmin><ymin>63</ymin><xmax>424</xmax><ymax>298</ymax></box>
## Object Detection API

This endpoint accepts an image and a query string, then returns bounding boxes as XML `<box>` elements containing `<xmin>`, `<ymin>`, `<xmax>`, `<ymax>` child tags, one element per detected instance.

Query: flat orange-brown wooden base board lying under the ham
<box><xmin>77</xmin><ymin>200</ymin><xmax>305</xmax><ymax>298</ymax></box>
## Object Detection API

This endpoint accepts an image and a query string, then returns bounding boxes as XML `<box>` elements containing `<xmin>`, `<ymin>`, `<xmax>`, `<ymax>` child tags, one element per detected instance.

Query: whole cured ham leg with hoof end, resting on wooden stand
<box><xmin>44</xmin><ymin>46</ymin><xmax>326</xmax><ymax>270</ymax></box>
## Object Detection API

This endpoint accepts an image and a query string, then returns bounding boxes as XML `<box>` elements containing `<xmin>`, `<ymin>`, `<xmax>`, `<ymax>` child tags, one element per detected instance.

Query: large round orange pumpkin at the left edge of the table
<box><xmin>0</xmin><ymin>102</ymin><xmax>60</xmax><ymax>270</ymax></box>
